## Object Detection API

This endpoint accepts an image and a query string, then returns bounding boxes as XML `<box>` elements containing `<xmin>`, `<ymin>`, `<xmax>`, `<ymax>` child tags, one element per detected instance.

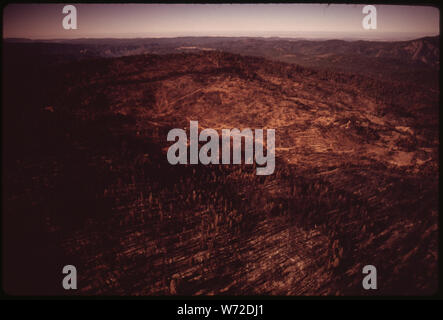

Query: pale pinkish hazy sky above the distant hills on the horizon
<box><xmin>3</xmin><ymin>4</ymin><xmax>439</xmax><ymax>39</ymax></box>
